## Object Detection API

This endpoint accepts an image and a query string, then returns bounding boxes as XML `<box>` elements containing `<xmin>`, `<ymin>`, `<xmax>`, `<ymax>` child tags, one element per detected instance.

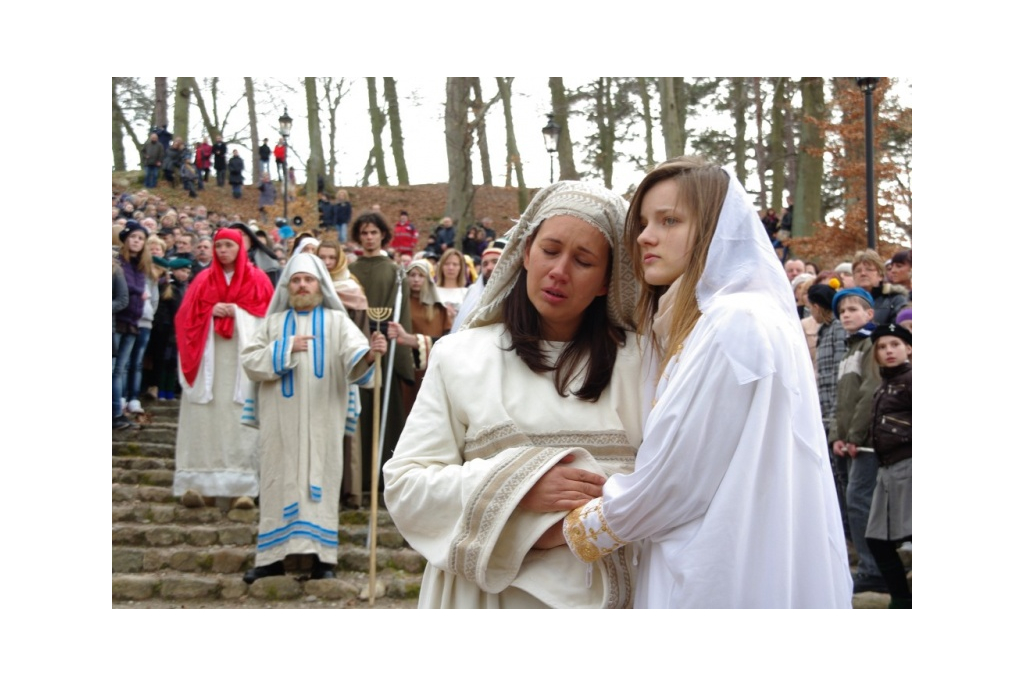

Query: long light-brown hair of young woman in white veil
<box><xmin>626</xmin><ymin>157</ymin><xmax>729</xmax><ymax>373</ymax></box>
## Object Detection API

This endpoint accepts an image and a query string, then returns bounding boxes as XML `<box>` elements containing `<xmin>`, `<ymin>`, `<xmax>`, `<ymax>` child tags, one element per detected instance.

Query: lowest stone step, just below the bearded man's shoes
<box><xmin>111</xmin><ymin>570</ymin><xmax>421</xmax><ymax>608</ymax></box>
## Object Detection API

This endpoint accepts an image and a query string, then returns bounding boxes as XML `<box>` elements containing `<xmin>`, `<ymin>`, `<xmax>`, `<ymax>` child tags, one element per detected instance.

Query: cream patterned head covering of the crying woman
<box><xmin>460</xmin><ymin>181</ymin><xmax>630</xmax><ymax>331</ymax></box>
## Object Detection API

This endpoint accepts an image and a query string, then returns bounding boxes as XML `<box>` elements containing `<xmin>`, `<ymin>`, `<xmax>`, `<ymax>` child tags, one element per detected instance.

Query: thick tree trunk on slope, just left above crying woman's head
<box><xmin>444</xmin><ymin>77</ymin><xmax>475</xmax><ymax>237</ymax></box>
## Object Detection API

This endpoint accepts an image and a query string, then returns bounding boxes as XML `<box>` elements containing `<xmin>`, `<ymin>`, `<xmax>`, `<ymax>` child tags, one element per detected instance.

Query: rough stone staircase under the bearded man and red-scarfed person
<box><xmin>111</xmin><ymin>401</ymin><xmax>425</xmax><ymax>608</ymax></box>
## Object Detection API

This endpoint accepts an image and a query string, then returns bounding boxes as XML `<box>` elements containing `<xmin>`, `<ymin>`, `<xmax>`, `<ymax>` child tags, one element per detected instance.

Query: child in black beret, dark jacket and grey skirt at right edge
<box><xmin>865</xmin><ymin>324</ymin><xmax>912</xmax><ymax>609</ymax></box>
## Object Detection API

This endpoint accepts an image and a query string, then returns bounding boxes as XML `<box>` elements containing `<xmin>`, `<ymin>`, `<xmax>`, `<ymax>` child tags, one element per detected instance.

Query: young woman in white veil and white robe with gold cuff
<box><xmin>563</xmin><ymin>158</ymin><xmax>852</xmax><ymax>608</ymax></box>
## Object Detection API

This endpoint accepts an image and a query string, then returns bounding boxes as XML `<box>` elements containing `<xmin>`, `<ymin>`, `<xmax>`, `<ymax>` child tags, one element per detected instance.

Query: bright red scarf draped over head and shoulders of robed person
<box><xmin>174</xmin><ymin>228</ymin><xmax>273</xmax><ymax>385</ymax></box>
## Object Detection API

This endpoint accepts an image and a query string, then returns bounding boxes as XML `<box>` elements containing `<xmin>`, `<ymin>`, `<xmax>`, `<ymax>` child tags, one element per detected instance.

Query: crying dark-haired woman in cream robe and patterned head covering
<box><xmin>384</xmin><ymin>181</ymin><xmax>641</xmax><ymax>608</ymax></box>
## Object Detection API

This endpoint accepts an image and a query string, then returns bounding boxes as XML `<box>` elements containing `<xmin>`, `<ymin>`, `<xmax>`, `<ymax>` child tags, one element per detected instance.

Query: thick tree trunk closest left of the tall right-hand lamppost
<box><xmin>793</xmin><ymin>77</ymin><xmax>825</xmax><ymax>238</ymax></box>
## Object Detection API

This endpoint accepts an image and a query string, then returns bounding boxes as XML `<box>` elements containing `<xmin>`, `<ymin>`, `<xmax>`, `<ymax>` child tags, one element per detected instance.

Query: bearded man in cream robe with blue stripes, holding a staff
<box><xmin>242</xmin><ymin>253</ymin><xmax>387</xmax><ymax>584</ymax></box>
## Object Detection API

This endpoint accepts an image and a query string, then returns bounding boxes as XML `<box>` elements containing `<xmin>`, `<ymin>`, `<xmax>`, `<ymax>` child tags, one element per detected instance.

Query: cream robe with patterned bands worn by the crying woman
<box><xmin>384</xmin><ymin>325</ymin><xmax>642</xmax><ymax>608</ymax></box>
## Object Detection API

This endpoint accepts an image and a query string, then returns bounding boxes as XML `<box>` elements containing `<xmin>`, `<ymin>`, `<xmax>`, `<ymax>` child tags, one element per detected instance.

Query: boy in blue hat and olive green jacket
<box><xmin>828</xmin><ymin>288</ymin><xmax>888</xmax><ymax>594</ymax></box>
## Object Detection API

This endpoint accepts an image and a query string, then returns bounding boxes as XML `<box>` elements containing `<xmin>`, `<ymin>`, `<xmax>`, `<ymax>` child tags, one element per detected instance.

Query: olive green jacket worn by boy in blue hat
<box><xmin>828</xmin><ymin>331</ymin><xmax>881</xmax><ymax>448</ymax></box>
